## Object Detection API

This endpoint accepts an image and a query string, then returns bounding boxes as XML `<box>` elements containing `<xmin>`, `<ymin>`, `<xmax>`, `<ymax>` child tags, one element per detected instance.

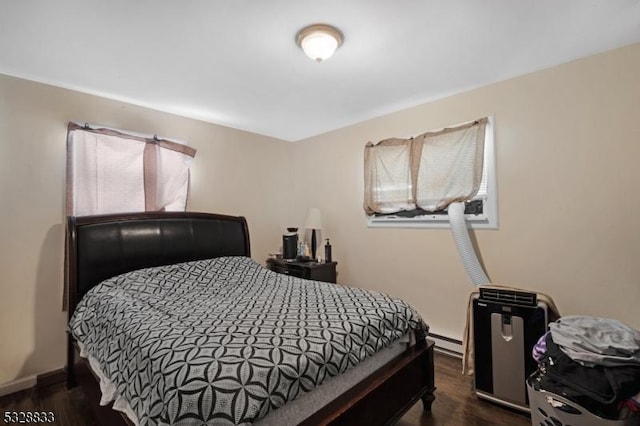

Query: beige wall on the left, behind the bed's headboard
<box><xmin>0</xmin><ymin>75</ymin><xmax>293</xmax><ymax>385</ymax></box>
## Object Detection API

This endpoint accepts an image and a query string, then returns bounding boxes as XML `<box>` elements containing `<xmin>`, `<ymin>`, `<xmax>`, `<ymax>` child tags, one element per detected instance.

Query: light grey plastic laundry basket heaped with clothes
<box><xmin>527</xmin><ymin>373</ymin><xmax>640</xmax><ymax>426</ymax></box>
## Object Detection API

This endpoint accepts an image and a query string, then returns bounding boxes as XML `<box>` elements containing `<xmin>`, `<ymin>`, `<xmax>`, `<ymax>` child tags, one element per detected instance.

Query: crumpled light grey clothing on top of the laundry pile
<box><xmin>549</xmin><ymin>315</ymin><xmax>640</xmax><ymax>367</ymax></box>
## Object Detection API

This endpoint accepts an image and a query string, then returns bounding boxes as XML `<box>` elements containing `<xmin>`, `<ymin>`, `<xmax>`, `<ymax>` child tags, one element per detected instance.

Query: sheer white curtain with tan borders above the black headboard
<box><xmin>67</xmin><ymin>123</ymin><xmax>196</xmax><ymax>216</ymax></box>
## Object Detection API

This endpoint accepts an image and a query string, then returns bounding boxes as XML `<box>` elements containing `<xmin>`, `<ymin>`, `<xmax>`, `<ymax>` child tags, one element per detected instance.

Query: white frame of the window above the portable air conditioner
<box><xmin>367</xmin><ymin>116</ymin><xmax>499</xmax><ymax>229</ymax></box>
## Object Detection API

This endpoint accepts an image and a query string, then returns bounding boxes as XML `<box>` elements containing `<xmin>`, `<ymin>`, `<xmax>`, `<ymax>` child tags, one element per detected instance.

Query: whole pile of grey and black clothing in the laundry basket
<box><xmin>533</xmin><ymin>316</ymin><xmax>640</xmax><ymax>420</ymax></box>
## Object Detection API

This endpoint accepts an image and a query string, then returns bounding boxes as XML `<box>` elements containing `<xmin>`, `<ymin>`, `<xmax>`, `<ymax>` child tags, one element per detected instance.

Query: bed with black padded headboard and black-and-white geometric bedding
<box><xmin>66</xmin><ymin>212</ymin><xmax>435</xmax><ymax>425</ymax></box>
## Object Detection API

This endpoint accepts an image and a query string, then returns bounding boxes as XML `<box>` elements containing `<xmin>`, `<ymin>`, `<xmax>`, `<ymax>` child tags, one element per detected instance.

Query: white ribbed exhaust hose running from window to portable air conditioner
<box><xmin>448</xmin><ymin>202</ymin><xmax>490</xmax><ymax>285</ymax></box>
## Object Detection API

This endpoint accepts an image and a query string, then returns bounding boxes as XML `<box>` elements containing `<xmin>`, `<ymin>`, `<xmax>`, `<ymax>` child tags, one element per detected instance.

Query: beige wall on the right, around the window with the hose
<box><xmin>294</xmin><ymin>44</ymin><xmax>640</xmax><ymax>339</ymax></box>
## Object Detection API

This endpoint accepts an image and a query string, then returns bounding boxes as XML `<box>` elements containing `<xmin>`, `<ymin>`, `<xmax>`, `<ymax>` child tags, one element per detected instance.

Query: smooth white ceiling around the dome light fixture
<box><xmin>0</xmin><ymin>0</ymin><xmax>640</xmax><ymax>141</ymax></box>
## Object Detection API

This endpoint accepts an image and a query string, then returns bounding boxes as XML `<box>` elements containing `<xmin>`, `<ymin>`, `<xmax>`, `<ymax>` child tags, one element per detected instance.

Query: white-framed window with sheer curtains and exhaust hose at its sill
<box><xmin>364</xmin><ymin>118</ymin><xmax>498</xmax><ymax>229</ymax></box>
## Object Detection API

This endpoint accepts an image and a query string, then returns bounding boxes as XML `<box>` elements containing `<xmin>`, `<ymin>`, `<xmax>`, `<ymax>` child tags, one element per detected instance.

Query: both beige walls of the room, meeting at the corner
<box><xmin>0</xmin><ymin>44</ymin><xmax>640</xmax><ymax>385</ymax></box>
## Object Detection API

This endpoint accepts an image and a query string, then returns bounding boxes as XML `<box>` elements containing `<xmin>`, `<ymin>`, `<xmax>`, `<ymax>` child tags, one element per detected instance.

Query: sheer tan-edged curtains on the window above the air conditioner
<box><xmin>364</xmin><ymin>118</ymin><xmax>488</xmax><ymax>215</ymax></box>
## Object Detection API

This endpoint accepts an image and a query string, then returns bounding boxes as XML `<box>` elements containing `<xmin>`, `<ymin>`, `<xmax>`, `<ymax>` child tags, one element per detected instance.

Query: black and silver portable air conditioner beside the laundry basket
<box><xmin>472</xmin><ymin>288</ymin><xmax>557</xmax><ymax>412</ymax></box>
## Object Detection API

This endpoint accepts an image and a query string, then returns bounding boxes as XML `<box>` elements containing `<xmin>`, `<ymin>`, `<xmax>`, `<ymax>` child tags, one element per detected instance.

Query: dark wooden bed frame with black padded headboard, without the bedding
<box><xmin>66</xmin><ymin>212</ymin><xmax>435</xmax><ymax>426</ymax></box>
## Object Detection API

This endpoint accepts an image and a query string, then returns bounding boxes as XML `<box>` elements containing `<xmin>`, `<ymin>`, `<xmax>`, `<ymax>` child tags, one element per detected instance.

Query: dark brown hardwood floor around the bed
<box><xmin>0</xmin><ymin>354</ymin><xmax>531</xmax><ymax>426</ymax></box>
